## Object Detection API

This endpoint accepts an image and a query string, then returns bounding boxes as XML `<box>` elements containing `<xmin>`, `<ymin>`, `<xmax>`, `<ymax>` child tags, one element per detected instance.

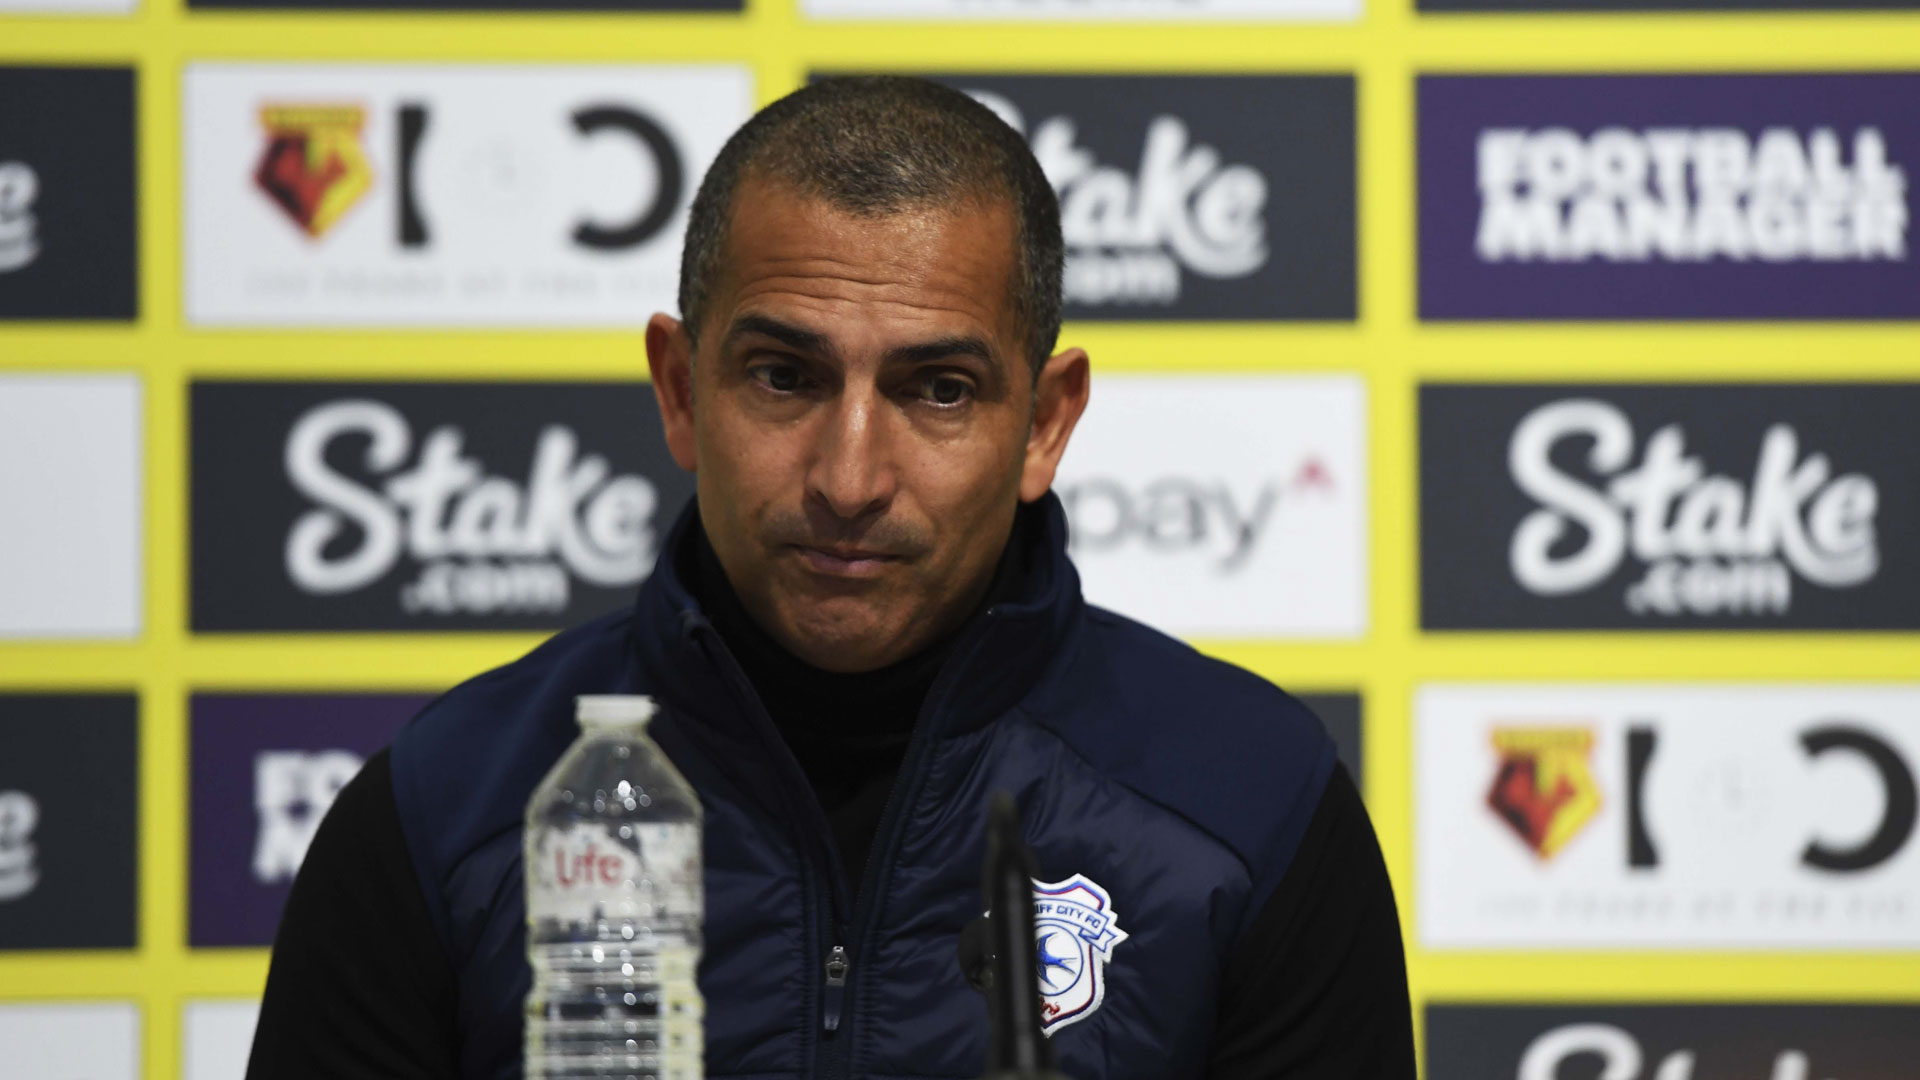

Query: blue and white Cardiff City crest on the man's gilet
<box><xmin>1033</xmin><ymin>874</ymin><xmax>1127</xmax><ymax>1036</ymax></box>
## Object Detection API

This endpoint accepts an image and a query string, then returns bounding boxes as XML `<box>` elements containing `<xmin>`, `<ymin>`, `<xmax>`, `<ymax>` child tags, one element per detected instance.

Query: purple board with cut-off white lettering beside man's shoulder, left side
<box><xmin>188</xmin><ymin>694</ymin><xmax>432</xmax><ymax>945</ymax></box>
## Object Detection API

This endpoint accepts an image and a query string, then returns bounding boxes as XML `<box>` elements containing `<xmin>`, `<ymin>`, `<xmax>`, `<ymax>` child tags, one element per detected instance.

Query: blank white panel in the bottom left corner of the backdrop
<box><xmin>0</xmin><ymin>1001</ymin><xmax>140</xmax><ymax>1080</ymax></box>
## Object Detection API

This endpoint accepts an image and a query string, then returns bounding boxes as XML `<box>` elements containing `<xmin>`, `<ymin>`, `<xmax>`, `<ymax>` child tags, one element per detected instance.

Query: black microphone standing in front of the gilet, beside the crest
<box><xmin>975</xmin><ymin>792</ymin><xmax>1066</xmax><ymax>1080</ymax></box>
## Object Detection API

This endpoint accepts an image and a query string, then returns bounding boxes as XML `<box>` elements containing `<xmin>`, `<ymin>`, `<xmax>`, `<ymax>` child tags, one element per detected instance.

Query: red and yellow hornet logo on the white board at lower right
<box><xmin>1486</xmin><ymin>726</ymin><xmax>1599</xmax><ymax>859</ymax></box>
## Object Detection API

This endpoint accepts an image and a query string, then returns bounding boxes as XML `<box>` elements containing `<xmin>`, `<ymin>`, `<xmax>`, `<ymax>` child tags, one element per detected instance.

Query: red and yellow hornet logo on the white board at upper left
<box><xmin>253</xmin><ymin>106</ymin><xmax>372</xmax><ymax>238</ymax></box>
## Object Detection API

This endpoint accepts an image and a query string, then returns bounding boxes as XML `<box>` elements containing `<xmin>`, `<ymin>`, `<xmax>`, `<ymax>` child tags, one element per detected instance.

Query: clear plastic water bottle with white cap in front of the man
<box><xmin>526</xmin><ymin>696</ymin><xmax>707</xmax><ymax>1080</ymax></box>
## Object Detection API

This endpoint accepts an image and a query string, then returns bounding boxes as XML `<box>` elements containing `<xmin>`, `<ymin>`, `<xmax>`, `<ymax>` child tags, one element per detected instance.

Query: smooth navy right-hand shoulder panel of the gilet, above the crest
<box><xmin>1033</xmin><ymin>607</ymin><xmax>1334</xmax><ymax>888</ymax></box>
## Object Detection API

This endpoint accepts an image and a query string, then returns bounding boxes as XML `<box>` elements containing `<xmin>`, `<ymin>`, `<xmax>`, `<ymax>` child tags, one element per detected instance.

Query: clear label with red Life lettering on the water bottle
<box><xmin>526</xmin><ymin>822</ymin><xmax>703</xmax><ymax>924</ymax></box>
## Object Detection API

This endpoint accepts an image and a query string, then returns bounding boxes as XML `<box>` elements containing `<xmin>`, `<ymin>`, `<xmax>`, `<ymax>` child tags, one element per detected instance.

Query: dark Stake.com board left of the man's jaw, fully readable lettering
<box><xmin>190</xmin><ymin>382</ymin><xmax>693</xmax><ymax>630</ymax></box>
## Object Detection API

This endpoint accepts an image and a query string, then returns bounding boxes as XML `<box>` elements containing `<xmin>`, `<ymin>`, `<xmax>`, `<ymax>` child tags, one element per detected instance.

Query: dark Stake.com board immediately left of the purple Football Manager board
<box><xmin>913</xmin><ymin>75</ymin><xmax>1356</xmax><ymax>321</ymax></box>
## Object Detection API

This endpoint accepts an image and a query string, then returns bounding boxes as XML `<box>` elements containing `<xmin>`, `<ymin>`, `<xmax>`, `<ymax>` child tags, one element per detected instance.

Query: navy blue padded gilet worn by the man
<box><xmin>392</xmin><ymin>494</ymin><xmax>1334</xmax><ymax>1080</ymax></box>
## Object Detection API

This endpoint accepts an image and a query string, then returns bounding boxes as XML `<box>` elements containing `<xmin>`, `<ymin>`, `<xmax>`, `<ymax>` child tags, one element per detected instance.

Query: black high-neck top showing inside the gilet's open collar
<box><xmin>680</xmin><ymin>507</ymin><xmax>1029</xmax><ymax>894</ymax></box>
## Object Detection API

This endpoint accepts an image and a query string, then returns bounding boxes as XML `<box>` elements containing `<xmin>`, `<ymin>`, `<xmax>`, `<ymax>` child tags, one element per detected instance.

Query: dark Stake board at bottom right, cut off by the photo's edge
<box><xmin>1427</xmin><ymin>1003</ymin><xmax>1920</xmax><ymax>1080</ymax></box>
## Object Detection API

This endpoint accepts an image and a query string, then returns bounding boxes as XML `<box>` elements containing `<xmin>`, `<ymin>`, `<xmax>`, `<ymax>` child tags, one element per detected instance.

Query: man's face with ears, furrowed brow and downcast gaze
<box><xmin>647</xmin><ymin>181</ymin><xmax>1087</xmax><ymax>671</ymax></box>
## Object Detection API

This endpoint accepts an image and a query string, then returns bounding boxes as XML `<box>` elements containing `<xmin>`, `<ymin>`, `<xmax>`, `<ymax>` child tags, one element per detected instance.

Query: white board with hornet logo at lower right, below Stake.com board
<box><xmin>1415</xmin><ymin>686</ymin><xmax>1920</xmax><ymax>949</ymax></box>
